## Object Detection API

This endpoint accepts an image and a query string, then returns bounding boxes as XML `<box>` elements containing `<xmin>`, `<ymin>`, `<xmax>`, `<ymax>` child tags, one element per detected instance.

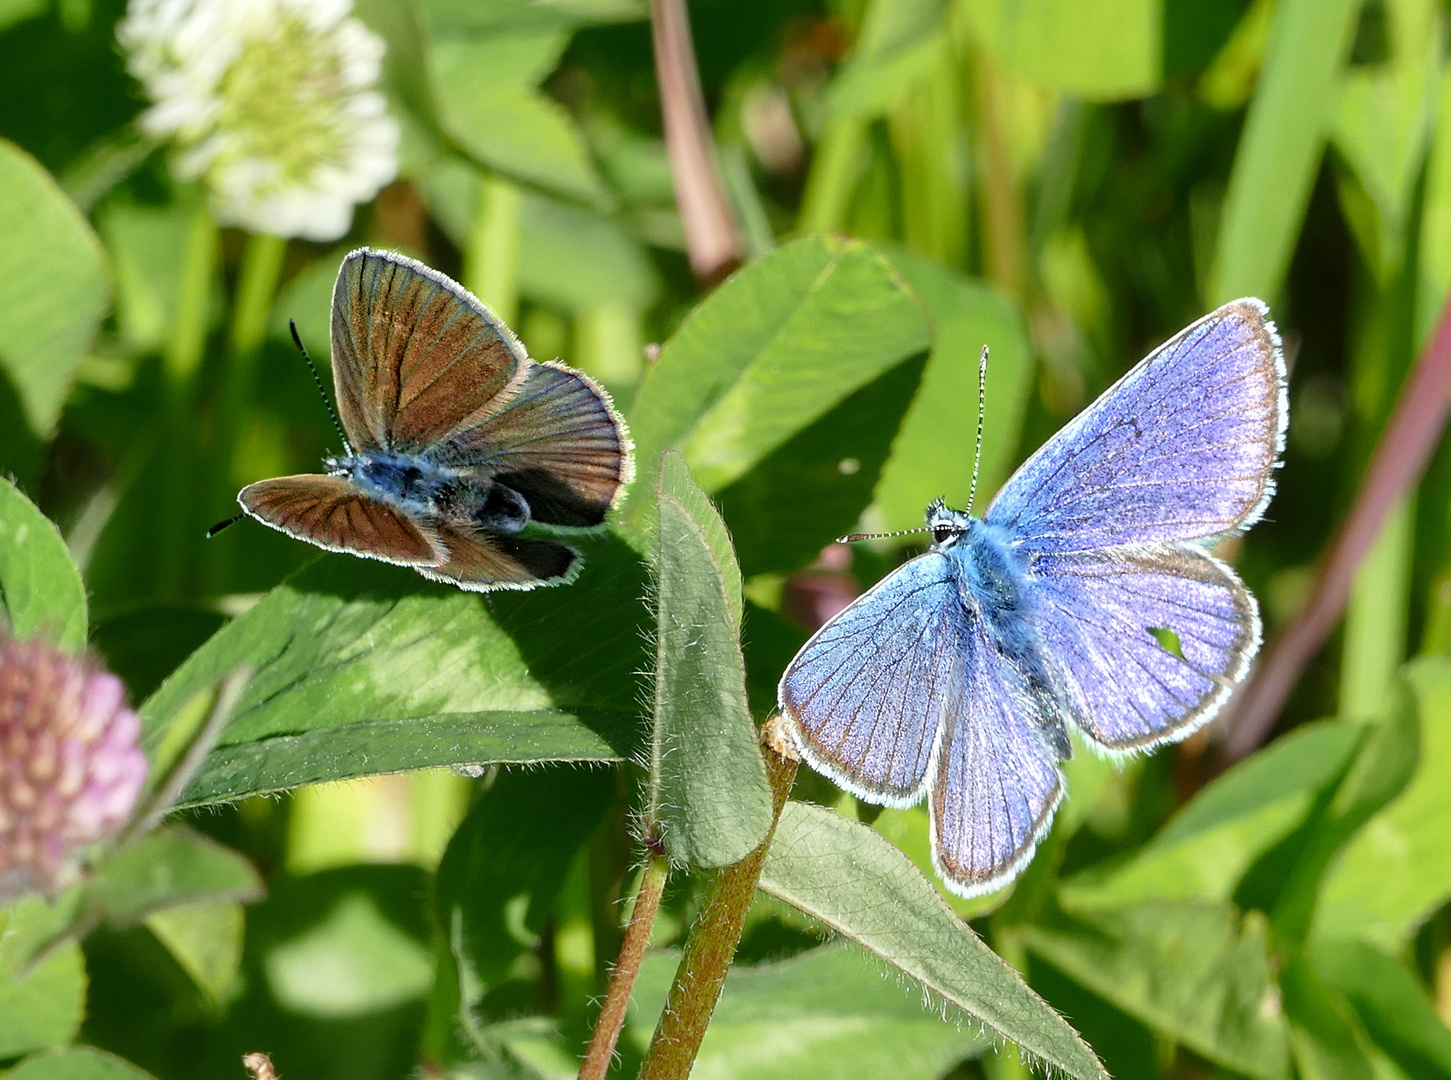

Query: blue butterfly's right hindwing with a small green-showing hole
<box><xmin>1035</xmin><ymin>544</ymin><xmax>1259</xmax><ymax>752</ymax></box>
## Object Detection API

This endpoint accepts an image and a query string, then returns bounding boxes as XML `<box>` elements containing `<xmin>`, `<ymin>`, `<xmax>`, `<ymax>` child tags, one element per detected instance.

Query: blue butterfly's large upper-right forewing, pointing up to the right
<box><xmin>987</xmin><ymin>299</ymin><xmax>1288</xmax><ymax>553</ymax></box>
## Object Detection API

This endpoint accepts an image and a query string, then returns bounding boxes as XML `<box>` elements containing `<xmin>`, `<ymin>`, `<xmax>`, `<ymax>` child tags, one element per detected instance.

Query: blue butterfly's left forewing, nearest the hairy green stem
<box><xmin>778</xmin><ymin>552</ymin><xmax>966</xmax><ymax>806</ymax></box>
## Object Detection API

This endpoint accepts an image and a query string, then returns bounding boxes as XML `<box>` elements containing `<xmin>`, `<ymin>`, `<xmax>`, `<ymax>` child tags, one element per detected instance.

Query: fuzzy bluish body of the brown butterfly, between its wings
<box><xmin>326</xmin><ymin>451</ymin><xmax>530</xmax><ymax>536</ymax></box>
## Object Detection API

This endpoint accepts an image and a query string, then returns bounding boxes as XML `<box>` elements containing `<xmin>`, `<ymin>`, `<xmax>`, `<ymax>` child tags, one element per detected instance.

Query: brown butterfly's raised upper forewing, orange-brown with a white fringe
<box><xmin>332</xmin><ymin>248</ymin><xmax>528</xmax><ymax>451</ymax></box>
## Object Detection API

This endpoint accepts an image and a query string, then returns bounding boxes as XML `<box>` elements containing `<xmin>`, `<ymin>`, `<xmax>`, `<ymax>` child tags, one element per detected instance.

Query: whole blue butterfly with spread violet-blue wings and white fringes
<box><xmin>778</xmin><ymin>299</ymin><xmax>1288</xmax><ymax>896</ymax></box>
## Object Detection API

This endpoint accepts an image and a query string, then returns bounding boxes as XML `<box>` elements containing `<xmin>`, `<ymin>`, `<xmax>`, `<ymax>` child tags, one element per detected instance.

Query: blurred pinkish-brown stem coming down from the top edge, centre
<box><xmin>650</xmin><ymin>0</ymin><xmax>741</xmax><ymax>283</ymax></box>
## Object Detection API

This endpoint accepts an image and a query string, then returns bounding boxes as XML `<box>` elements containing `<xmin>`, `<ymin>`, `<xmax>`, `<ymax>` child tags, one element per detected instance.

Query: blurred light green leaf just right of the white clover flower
<box><xmin>432</xmin><ymin>35</ymin><xmax>608</xmax><ymax>205</ymax></box>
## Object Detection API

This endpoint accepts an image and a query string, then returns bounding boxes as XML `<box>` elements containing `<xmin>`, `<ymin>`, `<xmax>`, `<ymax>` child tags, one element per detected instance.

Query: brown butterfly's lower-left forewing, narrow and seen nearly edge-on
<box><xmin>237</xmin><ymin>475</ymin><xmax>444</xmax><ymax>566</ymax></box>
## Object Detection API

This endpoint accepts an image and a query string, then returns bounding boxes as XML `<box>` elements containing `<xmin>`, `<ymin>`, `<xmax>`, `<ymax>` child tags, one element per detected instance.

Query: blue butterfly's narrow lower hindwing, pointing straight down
<box><xmin>927</xmin><ymin>624</ymin><xmax>1064</xmax><ymax>896</ymax></box>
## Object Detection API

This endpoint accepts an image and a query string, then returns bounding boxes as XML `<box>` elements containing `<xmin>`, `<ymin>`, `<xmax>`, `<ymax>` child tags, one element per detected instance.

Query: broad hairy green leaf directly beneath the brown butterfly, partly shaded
<box><xmin>141</xmin><ymin>534</ymin><xmax>647</xmax><ymax>806</ymax></box>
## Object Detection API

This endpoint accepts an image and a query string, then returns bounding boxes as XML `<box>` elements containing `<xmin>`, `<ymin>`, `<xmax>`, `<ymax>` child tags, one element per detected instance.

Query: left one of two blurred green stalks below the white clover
<box><xmin>157</xmin><ymin>199</ymin><xmax>218</xmax><ymax>595</ymax></box>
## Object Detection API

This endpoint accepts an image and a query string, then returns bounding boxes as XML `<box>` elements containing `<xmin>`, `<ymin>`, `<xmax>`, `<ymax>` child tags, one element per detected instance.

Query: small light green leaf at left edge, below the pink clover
<box><xmin>0</xmin><ymin>897</ymin><xmax>86</xmax><ymax>1060</ymax></box>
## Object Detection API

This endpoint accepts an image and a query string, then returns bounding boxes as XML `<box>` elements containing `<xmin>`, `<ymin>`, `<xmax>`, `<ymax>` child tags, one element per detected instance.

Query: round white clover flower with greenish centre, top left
<box><xmin>116</xmin><ymin>0</ymin><xmax>398</xmax><ymax>240</ymax></box>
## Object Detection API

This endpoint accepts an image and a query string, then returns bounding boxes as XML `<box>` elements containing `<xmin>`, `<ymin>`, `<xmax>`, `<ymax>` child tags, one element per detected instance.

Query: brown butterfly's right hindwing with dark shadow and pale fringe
<box><xmin>438</xmin><ymin>360</ymin><xmax>634</xmax><ymax>527</ymax></box>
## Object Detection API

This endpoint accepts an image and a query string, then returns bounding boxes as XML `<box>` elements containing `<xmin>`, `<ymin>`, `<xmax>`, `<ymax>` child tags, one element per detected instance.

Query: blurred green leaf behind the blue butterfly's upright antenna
<box><xmin>876</xmin><ymin>250</ymin><xmax>1033</xmax><ymax>530</ymax></box>
